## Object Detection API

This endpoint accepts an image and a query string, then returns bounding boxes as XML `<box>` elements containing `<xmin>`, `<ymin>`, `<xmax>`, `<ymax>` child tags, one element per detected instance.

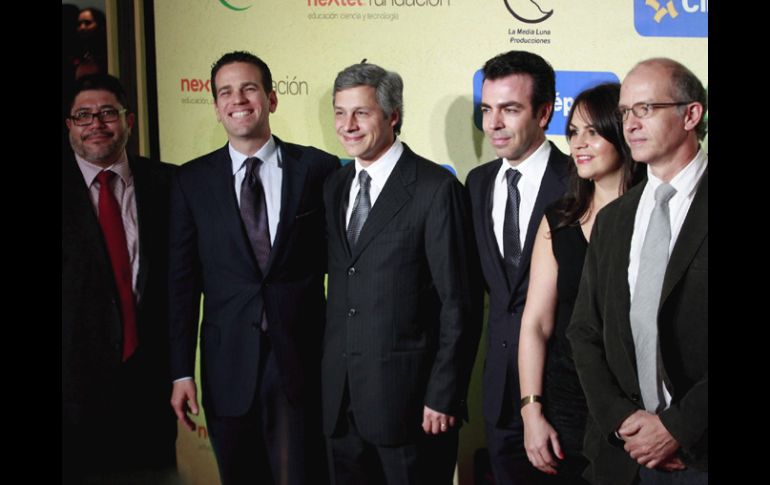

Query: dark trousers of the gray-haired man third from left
<box><xmin>327</xmin><ymin>389</ymin><xmax>459</xmax><ymax>485</ymax></box>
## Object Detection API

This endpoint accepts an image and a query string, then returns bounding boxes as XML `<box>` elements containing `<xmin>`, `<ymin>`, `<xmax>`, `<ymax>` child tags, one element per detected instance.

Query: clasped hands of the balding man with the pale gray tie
<box><xmin>618</xmin><ymin>410</ymin><xmax>684</xmax><ymax>469</ymax></box>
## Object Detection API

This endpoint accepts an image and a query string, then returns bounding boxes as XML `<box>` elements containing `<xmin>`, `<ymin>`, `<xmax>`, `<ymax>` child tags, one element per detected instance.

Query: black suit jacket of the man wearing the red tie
<box><xmin>61</xmin><ymin>150</ymin><xmax>176</xmax><ymax>463</ymax></box>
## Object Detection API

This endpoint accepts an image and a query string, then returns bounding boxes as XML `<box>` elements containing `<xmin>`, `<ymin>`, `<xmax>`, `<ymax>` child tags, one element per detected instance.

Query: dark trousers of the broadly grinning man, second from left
<box><xmin>206</xmin><ymin>333</ymin><xmax>327</xmax><ymax>485</ymax></box>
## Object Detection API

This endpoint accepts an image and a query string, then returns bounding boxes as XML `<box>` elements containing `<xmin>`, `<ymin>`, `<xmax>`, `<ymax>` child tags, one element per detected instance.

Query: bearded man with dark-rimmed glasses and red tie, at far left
<box><xmin>61</xmin><ymin>74</ymin><xmax>176</xmax><ymax>483</ymax></box>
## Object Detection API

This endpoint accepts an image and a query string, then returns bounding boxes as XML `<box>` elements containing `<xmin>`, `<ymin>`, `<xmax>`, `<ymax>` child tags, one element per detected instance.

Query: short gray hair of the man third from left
<box><xmin>334</xmin><ymin>62</ymin><xmax>404</xmax><ymax>135</ymax></box>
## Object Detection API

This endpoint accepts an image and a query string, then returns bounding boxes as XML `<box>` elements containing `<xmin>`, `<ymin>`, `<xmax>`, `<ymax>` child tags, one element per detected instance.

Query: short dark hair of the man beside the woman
<box><xmin>482</xmin><ymin>51</ymin><xmax>556</xmax><ymax>130</ymax></box>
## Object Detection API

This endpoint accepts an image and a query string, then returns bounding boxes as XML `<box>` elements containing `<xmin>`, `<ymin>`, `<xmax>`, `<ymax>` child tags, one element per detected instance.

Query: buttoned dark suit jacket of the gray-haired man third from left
<box><xmin>322</xmin><ymin>145</ymin><xmax>481</xmax><ymax>445</ymax></box>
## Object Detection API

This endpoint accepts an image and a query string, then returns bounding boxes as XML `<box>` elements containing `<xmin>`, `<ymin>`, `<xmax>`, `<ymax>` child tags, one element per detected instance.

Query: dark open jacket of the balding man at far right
<box><xmin>567</xmin><ymin>169</ymin><xmax>708</xmax><ymax>484</ymax></box>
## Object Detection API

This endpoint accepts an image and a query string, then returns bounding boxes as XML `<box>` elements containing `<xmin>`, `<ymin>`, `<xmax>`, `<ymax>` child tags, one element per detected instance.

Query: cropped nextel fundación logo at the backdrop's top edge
<box><xmin>304</xmin><ymin>0</ymin><xmax>456</xmax><ymax>22</ymax></box>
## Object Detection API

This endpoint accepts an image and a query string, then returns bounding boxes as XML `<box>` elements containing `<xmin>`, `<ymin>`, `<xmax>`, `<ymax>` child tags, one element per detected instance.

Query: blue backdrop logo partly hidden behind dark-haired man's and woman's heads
<box><xmin>473</xmin><ymin>69</ymin><xmax>620</xmax><ymax>135</ymax></box>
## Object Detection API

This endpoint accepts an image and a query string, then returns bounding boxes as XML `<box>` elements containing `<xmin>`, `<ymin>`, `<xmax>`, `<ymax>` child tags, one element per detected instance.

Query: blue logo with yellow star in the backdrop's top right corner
<box><xmin>634</xmin><ymin>0</ymin><xmax>709</xmax><ymax>37</ymax></box>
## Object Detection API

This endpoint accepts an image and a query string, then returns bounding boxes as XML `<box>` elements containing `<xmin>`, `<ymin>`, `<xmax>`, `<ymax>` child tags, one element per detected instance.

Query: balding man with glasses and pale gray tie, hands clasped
<box><xmin>567</xmin><ymin>58</ymin><xmax>708</xmax><ymax>485</ymax></box>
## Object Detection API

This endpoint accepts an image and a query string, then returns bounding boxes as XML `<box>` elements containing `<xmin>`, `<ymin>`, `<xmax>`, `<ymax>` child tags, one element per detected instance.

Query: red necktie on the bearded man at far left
<box><xmin>96</xmin><ymin>170</ymin><xmax>139</xmax><ymax>362</ymax></box>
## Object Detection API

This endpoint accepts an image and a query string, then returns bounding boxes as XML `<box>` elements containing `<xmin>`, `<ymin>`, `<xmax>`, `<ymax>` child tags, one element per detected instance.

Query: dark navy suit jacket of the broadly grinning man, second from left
<box><xmin>169</xmin><ymin>137</ymin><xmax>339</xmax><ymax>416</ymax></box>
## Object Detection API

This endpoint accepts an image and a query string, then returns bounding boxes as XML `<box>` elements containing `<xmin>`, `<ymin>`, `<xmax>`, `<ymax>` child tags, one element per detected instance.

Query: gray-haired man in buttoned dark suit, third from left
<box><xmin>322</xmin><ymin>63</ymin><xmax>481</xmax><ymax>485</ymax></box>
